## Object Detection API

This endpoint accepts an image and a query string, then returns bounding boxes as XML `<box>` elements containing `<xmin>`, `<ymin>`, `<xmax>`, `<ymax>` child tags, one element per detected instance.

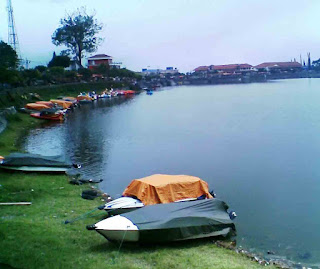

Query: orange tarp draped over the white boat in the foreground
<box><xmin>122</xmin><ymin>174</ymin><xmax>213</xmax><ymax>205</ymax></box>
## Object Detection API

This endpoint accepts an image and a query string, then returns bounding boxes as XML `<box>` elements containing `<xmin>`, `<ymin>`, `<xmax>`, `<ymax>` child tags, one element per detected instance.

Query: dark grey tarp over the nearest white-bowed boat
<box><xmin>121</xmin><ymin>199</ymin><xmax>236</xmax><ymax>242</ymax></box>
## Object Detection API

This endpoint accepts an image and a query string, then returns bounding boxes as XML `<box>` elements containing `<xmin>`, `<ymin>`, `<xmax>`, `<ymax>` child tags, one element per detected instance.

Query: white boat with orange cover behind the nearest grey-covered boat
<box><xmin>99</xmin><ymin>174</ymin><xmax>214</xmax><ymax>216</ymax></box>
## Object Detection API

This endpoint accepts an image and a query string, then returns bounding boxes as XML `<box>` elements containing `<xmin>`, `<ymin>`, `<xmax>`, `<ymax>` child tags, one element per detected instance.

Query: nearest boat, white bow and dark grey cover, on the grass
<box><xmin>87</xmin><ymin>199</ymin><xmax>235</xmax><ymax>243</ymax></box>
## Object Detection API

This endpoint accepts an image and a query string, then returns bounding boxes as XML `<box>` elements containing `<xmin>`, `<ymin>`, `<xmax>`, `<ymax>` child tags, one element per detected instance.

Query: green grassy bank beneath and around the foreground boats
<box><xmin>0</xmin><ymin>114</ymin><xmax>271</xmax><ymax>269</ymax></box>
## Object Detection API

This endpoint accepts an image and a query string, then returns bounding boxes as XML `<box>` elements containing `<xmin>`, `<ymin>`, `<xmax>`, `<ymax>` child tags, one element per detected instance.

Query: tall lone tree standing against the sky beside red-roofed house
<box><xmin>52</xmin><ymin>8</ymin><xmax>102</xmax><ymax>66</ymax></box>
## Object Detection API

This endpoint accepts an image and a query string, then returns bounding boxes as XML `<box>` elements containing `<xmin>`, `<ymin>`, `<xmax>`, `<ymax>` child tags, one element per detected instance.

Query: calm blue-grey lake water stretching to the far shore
<box><xmin>24</xmin><ymin>79</ymin><xmax>320</xmax><ymax>264</ymax></box>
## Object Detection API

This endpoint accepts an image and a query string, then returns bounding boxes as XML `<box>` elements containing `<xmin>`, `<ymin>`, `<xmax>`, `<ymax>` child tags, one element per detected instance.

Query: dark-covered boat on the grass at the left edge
<box><xmin>0</xmin><ymin>153</ymin><xmax>81</xmax><ymax>173</ymax></box>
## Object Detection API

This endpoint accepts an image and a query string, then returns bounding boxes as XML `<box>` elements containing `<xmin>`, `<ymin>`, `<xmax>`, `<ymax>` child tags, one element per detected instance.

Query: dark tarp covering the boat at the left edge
<box><xmin>2</xmin><ymin>153</ymin><xmax>72</xmax><ymax>167</ymax></box>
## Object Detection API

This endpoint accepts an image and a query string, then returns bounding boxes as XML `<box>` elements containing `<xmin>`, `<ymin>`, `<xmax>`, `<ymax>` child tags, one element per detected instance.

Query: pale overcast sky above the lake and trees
<box><xmin>0</xmin><ymin>0</ymin><xmax>320</xmax><ymax>72</ymax></box>
